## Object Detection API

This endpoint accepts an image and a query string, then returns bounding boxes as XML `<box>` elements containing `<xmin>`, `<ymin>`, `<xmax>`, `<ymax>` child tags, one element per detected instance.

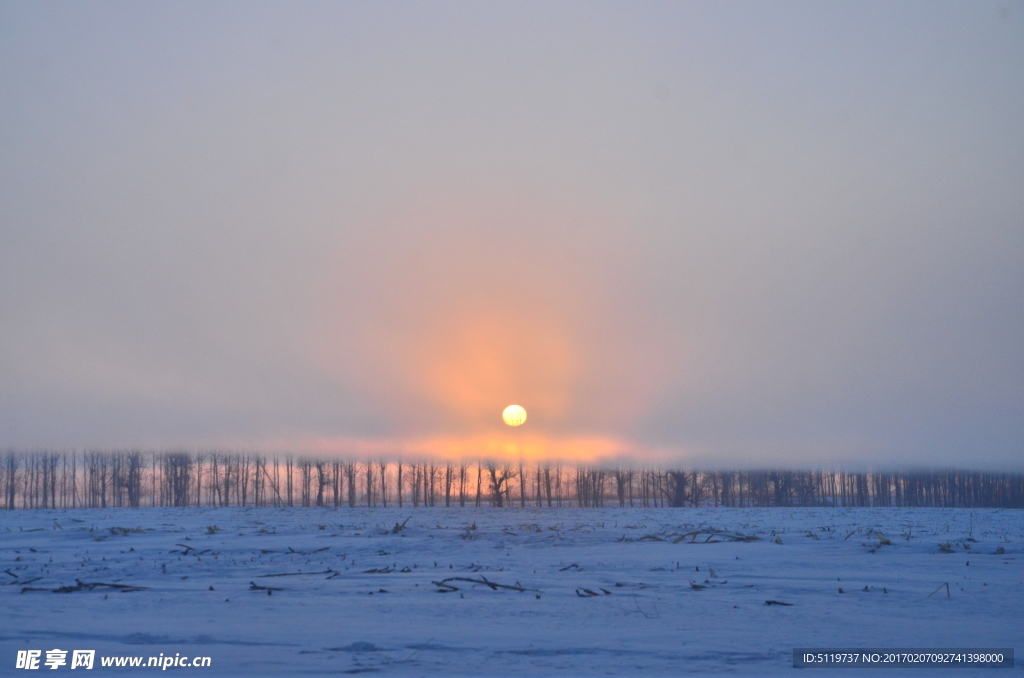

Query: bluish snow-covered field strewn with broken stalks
<box><xmin>0</xmin><ymin>507</ymin><xmax>1024</xmax><ymax>677</ymax></box>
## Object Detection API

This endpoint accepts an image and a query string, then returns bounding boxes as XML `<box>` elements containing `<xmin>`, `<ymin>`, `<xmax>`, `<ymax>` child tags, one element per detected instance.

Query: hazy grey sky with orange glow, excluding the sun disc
<box><xmin>0</xmin><ymin>0</ymin><xmax>1024</xmax><ymax>469</ymax></box>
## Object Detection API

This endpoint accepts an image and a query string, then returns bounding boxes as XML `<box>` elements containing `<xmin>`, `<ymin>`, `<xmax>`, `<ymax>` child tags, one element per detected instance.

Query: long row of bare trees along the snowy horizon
<box><xmin>0</xmin><ymin>451</ymin><xmax>1024</xmax><ymax>510</ymax></box>
